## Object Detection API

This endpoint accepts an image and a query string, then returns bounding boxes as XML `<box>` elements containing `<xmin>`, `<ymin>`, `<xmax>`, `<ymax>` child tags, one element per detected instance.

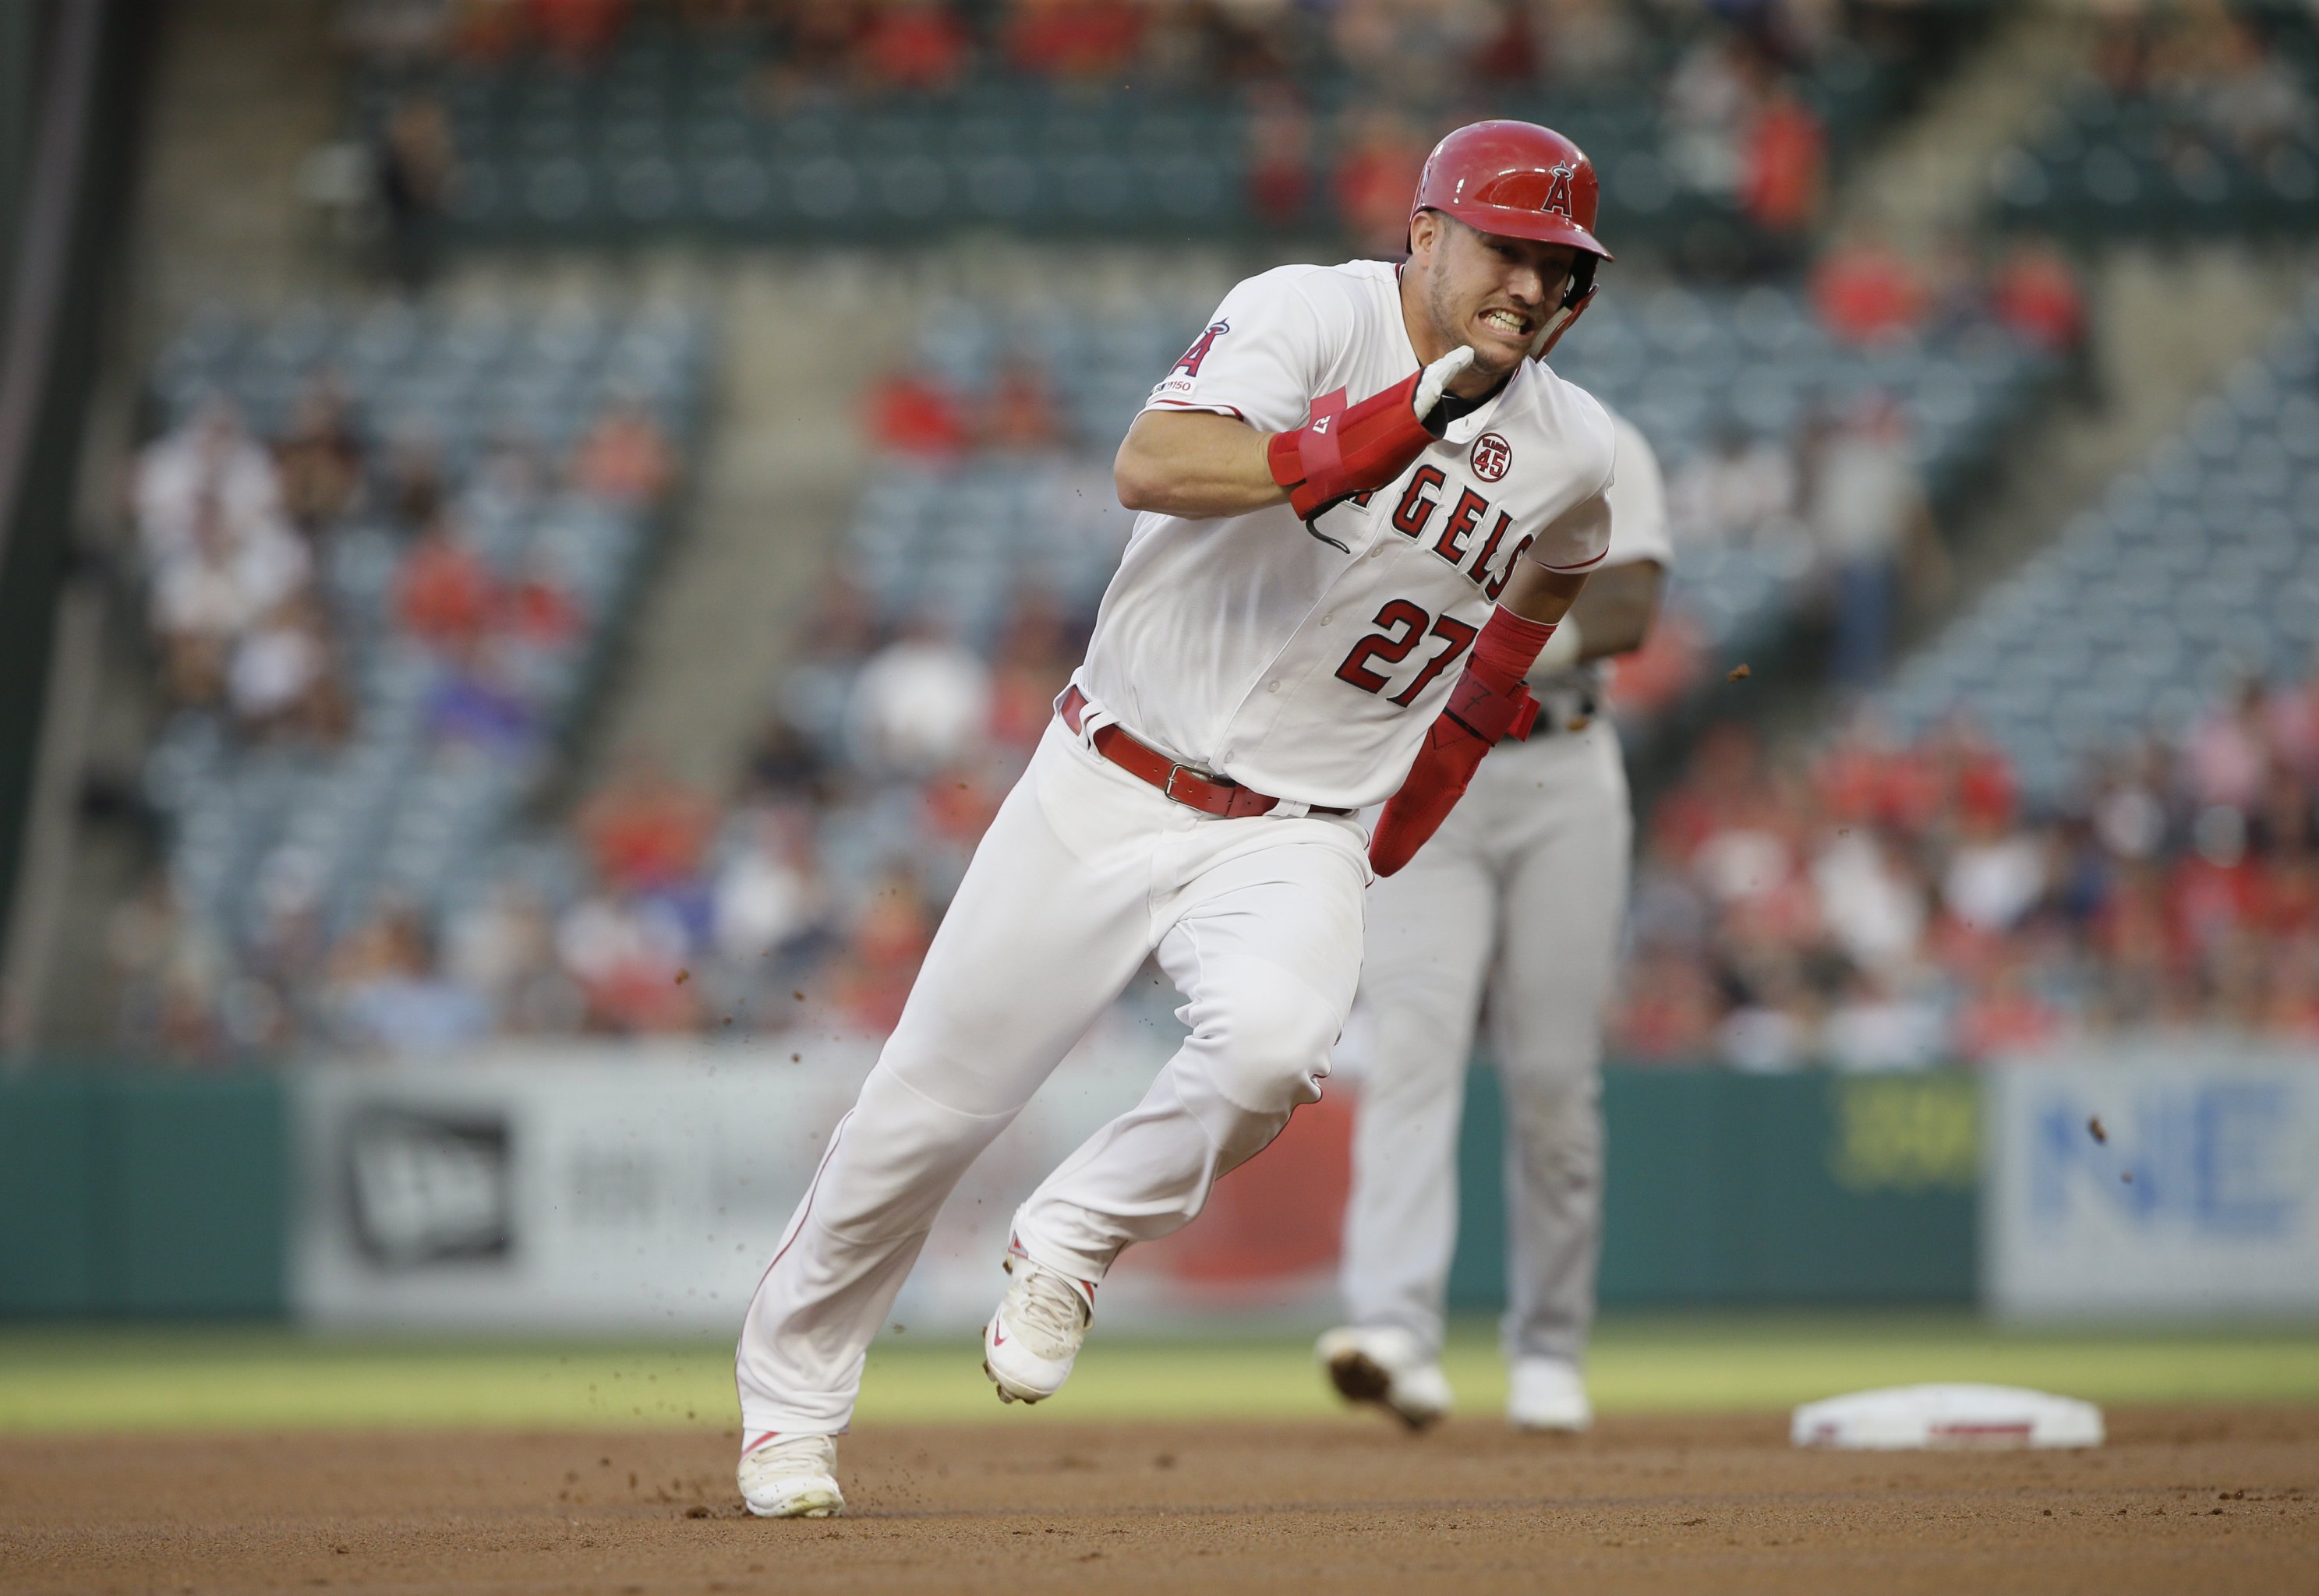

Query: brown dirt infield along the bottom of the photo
<box><xmin>0</xmin><ymin>1408</ymin><xmax>2319</xmax><ymax>1596</ymax></box>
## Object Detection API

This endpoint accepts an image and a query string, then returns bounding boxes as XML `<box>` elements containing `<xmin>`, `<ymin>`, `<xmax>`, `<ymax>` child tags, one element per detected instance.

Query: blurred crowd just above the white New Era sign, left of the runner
<box><xmin>114</xmin><ymin>568</ymin><xmax>1085</xmax><ymax>1055</ymax></box>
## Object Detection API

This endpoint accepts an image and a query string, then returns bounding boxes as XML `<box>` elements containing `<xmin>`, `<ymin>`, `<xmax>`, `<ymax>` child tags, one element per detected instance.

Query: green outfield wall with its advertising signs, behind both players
<box><xmin>0</xmin><ymin>1040</ymin><xmax>2319</xmax><ymax>1334</ymax></box>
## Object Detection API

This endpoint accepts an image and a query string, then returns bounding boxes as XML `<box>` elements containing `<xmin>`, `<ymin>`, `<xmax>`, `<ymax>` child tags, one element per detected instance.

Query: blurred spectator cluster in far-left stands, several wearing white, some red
<box><xmin>130</xmin><ymin>392</ymin><xmax>675</xmax><ymax>749</ymax></box>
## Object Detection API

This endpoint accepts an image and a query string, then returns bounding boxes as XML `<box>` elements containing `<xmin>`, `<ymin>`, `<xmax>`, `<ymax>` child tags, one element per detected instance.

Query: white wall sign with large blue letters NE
<box><xmin>1981</xmin><ymin>1037</ymin><xmax>2319</xmax><ymax>1318</ymax></box>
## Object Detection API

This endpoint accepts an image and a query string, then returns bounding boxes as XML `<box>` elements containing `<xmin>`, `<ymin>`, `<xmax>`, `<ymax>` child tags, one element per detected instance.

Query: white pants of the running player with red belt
<box><xmin>735</xmin><ymin>722</ymin><xmax>1368</xmax><ymax>1434</ymax></box>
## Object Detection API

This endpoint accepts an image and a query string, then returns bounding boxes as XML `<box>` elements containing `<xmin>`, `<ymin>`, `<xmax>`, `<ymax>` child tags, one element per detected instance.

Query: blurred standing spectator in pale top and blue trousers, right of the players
<box><xmin>1807</xmin><ymin>394</ymin><xmax>1946</xmax><ymax>687</ymax></box>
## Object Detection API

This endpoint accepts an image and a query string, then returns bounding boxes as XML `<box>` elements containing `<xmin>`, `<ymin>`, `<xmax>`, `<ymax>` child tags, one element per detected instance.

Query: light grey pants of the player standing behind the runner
<box><xmin>1343</xmin><ymin>717</ymin><xmax>1632</xmax><ymax>1361</ymax></box>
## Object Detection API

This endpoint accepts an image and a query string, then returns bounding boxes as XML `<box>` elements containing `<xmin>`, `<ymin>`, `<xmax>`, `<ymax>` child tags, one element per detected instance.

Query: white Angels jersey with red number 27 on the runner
<box><xmin>1076</xmin><ymin>260</ymin><xmax>1617</xmax><ymax>810</ymax></box>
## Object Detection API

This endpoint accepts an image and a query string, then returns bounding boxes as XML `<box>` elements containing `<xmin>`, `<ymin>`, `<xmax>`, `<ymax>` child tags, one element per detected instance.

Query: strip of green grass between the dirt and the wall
<box><xmin>0</xmin><ymin>1315</ymin><xmax>2319</xmax><ymax>1434</ymax></box>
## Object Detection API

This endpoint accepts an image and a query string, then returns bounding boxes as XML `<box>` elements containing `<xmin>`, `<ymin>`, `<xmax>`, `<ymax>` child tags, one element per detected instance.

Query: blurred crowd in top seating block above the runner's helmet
<box><xmin>345</xmin><ymin>0</ymin><xmax>1915</xmax><ymax>260</ymax></box>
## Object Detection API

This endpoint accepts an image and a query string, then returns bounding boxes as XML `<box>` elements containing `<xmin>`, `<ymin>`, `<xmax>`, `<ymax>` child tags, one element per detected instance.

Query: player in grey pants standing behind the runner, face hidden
<box><xmin>1317</xmin><ymin>405</ymin><xmax>1672</xmax><ymax>1432</ymax></box>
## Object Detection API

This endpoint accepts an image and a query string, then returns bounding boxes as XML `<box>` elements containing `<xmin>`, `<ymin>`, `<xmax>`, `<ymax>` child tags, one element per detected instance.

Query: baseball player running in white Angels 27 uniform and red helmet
<box><xmin>735</xmin><ymin>123</ymin><xmax>1614</xmax><ymax>1517</ymax></box>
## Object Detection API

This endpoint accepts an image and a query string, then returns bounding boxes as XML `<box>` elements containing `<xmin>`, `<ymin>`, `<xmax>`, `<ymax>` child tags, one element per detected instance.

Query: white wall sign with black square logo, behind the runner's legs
<box><xmin>292</xmin><ymin>1037</ymin><xmax>1164</xmax><ymax>1334</ymax></box>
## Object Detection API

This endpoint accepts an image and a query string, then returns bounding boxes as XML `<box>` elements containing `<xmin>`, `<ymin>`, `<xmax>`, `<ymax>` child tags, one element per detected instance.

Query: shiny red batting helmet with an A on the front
<box><xmin>1410</xmin><ymin>123</ymin><xmax>1612</xmax><ymax>357</ymax></box>
